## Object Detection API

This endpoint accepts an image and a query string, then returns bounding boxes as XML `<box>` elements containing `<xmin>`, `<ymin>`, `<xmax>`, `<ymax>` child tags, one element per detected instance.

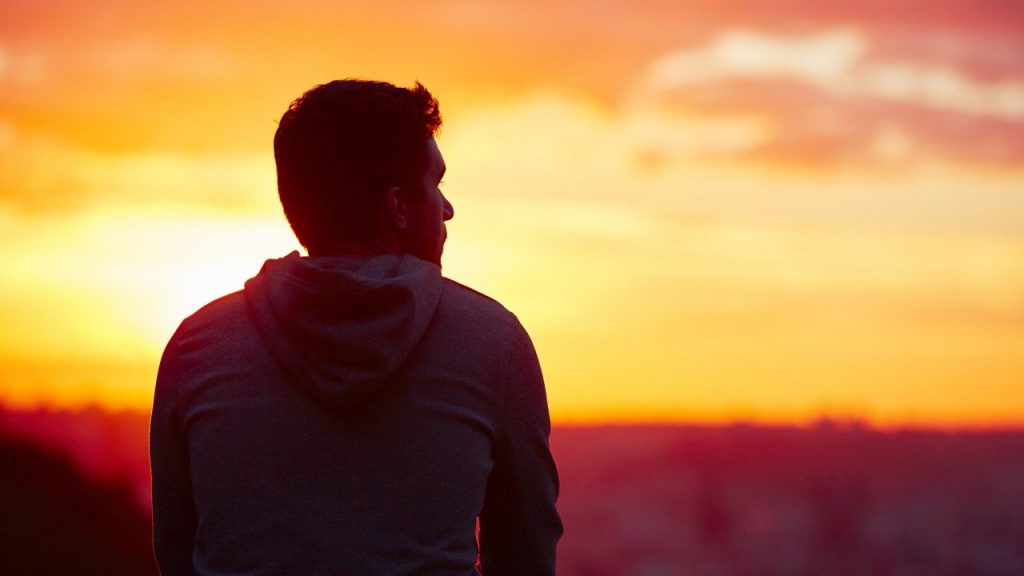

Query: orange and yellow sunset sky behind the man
<box><xmin>0</xmin><ymin>0</ymin><xmax>1024</xmax><ymax>426</ymax></box>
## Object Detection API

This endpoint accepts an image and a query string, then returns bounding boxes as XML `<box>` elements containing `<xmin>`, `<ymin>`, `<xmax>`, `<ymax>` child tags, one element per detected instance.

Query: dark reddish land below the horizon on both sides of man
<box><xmin>0</xmin><ymin>409</ymin><xmax>1024</xmax><ymax>576</ymax></box>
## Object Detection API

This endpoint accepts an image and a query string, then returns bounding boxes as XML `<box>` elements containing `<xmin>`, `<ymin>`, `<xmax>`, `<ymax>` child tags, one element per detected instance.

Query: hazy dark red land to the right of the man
<box><xmin>552</xmin><ymin>423</ymin><xmax>1024</xmax><ymax>576</ymax></box>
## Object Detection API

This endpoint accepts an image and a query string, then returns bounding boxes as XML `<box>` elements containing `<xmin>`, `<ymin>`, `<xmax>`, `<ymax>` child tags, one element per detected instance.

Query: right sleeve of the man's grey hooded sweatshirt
<box><xmin>479</xmin><ymin>322</ymin><xmax>562</xmax><ymax>576</ymax></box>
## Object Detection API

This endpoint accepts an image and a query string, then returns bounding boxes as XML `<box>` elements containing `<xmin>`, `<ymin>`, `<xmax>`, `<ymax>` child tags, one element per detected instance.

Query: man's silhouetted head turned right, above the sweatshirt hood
<box><xmin>273</xmin><ymin>80</ymin><xmax>453</xmax><ymax>264</ymax></box>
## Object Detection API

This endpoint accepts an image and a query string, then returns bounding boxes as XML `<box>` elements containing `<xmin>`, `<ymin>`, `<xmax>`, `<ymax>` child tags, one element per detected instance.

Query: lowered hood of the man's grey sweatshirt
<box><xmin>245</xmin><ymin>252</ymin><xmax>442</xmax><ymax>408</ymax></box>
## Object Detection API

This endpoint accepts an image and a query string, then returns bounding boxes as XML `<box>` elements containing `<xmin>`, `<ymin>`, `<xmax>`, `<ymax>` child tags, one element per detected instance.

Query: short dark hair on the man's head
<box><xmin>273</xmin><ymin>80</ymin><xmax>441</xmax><ymax>253</ymax></box>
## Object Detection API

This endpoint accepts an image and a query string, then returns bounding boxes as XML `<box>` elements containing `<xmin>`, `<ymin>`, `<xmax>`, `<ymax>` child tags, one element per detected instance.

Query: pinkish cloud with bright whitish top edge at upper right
<box><xmin>632</xmin><ymin>28</ymin><xmax>1024</xmax><ymax>164</ymax></box>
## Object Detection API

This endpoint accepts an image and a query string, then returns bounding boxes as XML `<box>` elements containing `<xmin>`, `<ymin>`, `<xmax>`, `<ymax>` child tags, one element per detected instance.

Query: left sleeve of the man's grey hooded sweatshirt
<box><xmin>150</xmin><ymin>330</ymin><xmax>197</xmax><ymax>576</ymax></box>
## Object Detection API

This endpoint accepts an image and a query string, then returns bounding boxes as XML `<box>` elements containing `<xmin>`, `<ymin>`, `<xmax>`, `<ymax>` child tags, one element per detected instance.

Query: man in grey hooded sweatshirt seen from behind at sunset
<box><xmin>151</xmin><ymin>80</ymin><xmax>562</xmax><ymax>576</ymax></box>
